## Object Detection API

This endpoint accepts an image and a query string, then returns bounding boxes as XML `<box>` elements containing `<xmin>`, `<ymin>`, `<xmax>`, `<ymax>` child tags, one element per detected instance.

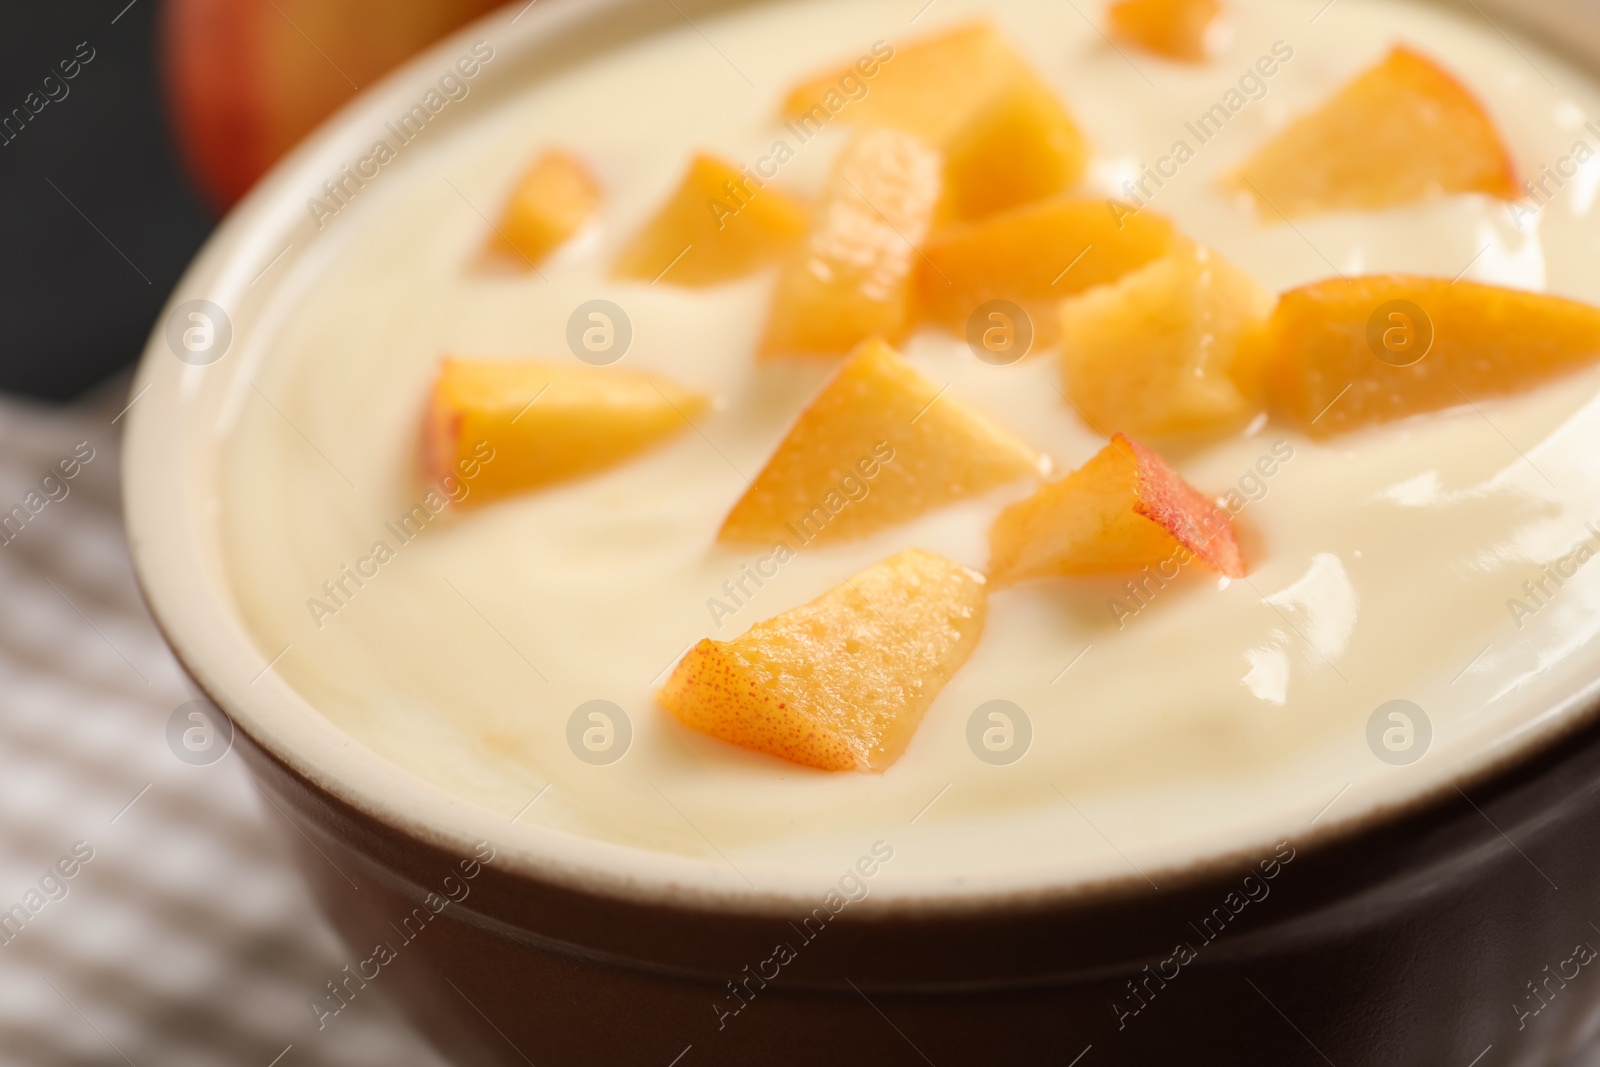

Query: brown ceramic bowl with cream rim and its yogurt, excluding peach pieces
<box><xmin>125</xmin><ymin>0</ymin><xmax>1600</xmax><ymax>1067</ymax></box>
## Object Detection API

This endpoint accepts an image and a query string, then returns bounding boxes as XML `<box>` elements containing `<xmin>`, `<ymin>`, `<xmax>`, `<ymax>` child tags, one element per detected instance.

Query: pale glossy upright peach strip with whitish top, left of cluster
<box><xmin>762</xmin><ymin>126</ymin><xmax>941</xmax><ymax>355</ymax></box>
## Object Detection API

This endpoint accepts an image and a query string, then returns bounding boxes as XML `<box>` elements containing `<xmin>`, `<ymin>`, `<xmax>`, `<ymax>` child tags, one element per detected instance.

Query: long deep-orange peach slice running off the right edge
<box><xmin>1262</xmin><ymin>274</ymin><xmax>1600</xmax><ymax>437</ymax></box>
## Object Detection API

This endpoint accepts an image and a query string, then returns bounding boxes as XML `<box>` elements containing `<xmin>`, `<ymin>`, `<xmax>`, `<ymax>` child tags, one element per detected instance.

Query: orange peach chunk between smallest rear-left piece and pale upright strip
<box><xmin>611</xmin><ymin>155</ymin><xmax>806</xmax><ymax>286</ymax></box>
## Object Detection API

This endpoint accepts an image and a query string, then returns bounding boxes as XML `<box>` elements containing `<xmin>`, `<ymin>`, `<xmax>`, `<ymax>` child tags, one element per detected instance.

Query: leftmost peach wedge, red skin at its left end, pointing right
<box><xmin>422</xmin><ymin>357</ymin><xmax>706</xmax><ymax>502</ymax></box>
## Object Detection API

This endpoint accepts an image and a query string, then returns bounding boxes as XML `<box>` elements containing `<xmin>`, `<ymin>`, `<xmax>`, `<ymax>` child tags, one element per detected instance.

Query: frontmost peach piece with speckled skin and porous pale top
<box><xmin>658</xmin><ymin>549</ymin><xmax>986</xmax><ymax>771</ymax></box>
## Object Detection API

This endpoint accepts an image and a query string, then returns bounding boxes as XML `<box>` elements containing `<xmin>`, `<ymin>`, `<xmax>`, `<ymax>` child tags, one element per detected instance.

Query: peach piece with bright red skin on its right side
<box><xmin>989</xmin><ymin>434</ymin><xmax>1245</xmax><ymax>585</ymax></box>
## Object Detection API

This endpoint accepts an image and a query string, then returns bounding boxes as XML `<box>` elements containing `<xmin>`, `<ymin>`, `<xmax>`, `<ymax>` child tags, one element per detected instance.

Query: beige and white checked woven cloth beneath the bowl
<box><xmin>0</xmin><ymin>390</ymin><xmax>442</xmax><ymax>1067</ymax></box>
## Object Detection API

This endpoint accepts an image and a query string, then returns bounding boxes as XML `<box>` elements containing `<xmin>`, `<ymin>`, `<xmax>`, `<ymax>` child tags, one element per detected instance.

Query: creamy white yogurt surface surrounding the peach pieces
<box><xmin>219</xmin><ymin>0</ymin><xmax>1600</xmax><ymax>886</ymax></box>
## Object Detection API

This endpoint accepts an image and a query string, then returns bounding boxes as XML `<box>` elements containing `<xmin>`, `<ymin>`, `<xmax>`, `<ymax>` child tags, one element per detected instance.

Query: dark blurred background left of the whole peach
<box><xmin>0</xmin><ymin>0</ymin><xmax>214</xmax><ymax>400</ymax></box>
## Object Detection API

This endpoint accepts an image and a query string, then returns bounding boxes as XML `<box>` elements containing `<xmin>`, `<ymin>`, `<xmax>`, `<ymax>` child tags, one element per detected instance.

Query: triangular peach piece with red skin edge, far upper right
<box><xmin>1229</xmin><ymin>48</ymin><xmax>1517</xmax><ymax>218</ymax></box>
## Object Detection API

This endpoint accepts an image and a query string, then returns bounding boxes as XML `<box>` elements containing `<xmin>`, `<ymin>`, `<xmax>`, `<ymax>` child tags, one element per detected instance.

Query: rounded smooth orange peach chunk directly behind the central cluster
<box><xmin>944</xmin><ymin>79</ymin><xmax>1088</xmax><ymax>219</ymax></box>
